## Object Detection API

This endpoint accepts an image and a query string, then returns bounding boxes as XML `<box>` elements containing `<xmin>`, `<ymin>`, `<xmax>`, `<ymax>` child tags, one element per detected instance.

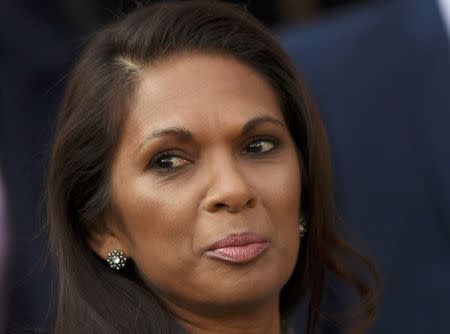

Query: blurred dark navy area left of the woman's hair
<box><xmin>0</xmin><ymin>0</ymin><xmax>76</xmax><ymax>333</ymax></box>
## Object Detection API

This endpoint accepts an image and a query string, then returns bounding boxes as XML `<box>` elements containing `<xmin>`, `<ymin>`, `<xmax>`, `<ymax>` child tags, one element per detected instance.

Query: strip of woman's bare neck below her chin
<box><xmin>171</xmin><ymin>298</ymin><xmax>281</xmax><ymax>334</ymax></box>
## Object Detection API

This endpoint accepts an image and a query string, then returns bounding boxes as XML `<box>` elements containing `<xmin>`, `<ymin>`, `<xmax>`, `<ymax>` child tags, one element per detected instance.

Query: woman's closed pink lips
<box><xmin>205</xmin><ymin>233</ymin><xmax>269</xmax><ymax>263</ymax></box>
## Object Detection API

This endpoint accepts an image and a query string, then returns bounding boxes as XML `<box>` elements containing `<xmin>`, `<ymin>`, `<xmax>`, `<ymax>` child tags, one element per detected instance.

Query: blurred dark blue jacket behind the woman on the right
<box><xmin>280</xmin><ymin>0</ymin><xmax>450</xmax><ymax>334</ymax></box>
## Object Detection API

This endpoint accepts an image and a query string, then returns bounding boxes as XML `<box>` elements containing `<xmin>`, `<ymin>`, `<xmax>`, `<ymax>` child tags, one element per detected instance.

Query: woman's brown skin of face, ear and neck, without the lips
<box><xmin>91</xmin><ymin>54</ymin><xmax>301</xmax><ymax>333</ymax></box>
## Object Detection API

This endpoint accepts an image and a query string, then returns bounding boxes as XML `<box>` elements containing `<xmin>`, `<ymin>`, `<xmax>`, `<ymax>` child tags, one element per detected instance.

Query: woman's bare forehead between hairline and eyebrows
<box><xmin>123</xmin><ymin>54</ymin><xmax>282</xmax><ymax>138</ymax></box>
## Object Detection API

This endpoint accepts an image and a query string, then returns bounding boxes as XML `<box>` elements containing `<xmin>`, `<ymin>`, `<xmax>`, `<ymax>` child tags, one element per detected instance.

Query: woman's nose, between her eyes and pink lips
<box><xmin>205</xmin><ymin>155</ymin><xmax>256</xmax><ymax>213</ymax></box>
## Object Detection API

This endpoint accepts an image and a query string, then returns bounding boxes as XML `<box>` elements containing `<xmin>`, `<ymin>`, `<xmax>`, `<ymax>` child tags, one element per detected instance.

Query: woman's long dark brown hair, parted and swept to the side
<box><xmin>48</xmin><ymin>1</ymin><xmax>377</xmax><ymax>334</ymax></box>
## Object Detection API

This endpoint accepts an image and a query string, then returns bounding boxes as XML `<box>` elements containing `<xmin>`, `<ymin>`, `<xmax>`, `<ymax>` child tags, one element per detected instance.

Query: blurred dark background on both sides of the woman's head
<box><xmin>0</xmin><ymin>0</ymin><xmax>450</xmax><ymax>333</ymax></box>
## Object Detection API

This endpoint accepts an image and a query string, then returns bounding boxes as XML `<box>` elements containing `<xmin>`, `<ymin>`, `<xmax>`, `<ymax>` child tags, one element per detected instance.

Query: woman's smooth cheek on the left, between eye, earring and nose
<box><xmin>112</xmin><ymin>176</ymin><xmax>195</xmax><ymax>283</ymax></box>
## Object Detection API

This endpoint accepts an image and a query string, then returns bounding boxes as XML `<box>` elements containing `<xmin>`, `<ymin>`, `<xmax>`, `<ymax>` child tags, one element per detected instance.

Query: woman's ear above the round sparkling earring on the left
<box><xmin>87</xmin><ymin>220</ymin><xmax>130</xmax><ymax>260</ymax></box>
